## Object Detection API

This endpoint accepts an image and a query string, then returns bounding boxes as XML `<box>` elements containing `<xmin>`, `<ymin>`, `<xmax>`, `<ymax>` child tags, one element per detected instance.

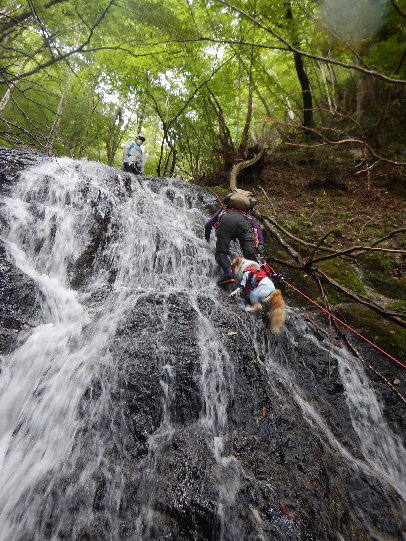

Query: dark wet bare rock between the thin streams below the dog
<box><xmin>32</xmin><ymin>294</ymin><xmax>402</xmax><ymax>541</ymax></box>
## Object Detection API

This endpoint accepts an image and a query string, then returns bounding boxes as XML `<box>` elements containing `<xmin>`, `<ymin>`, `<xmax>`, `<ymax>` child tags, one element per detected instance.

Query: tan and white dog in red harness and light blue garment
<box><xmin>231</xmin><ymin>257</ymin><xmax>286</xmax><ymax>333</ymax></box>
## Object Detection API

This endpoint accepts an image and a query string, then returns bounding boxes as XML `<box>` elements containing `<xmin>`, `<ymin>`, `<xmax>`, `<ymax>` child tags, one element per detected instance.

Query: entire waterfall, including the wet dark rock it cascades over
<box><xmin>0</xmin><ymin>153</ymin><xmax>405</xmax><ymax>541</ymax></box>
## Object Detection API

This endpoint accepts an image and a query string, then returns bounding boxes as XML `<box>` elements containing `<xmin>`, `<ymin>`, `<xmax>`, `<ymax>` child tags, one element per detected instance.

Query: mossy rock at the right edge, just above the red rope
<box><xmin>335</xmin><ymin>303</ymin><xmax>406</xmax><ymax>359</ymax></box>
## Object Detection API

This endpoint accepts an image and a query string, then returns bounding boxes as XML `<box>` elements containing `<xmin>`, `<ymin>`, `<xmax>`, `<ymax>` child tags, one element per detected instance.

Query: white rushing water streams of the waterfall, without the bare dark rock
<box><xmin>0</xmin><ymin>154</ymin><xmax>403</xmax><ymax>541</ymax></box>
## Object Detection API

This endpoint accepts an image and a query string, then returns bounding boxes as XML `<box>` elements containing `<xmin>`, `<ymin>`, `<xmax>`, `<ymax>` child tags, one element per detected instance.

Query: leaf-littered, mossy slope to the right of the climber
<box><xmin>205</xmin><ymin>175</ymin><xmax>406</xmax><ymax>358</ymax></box>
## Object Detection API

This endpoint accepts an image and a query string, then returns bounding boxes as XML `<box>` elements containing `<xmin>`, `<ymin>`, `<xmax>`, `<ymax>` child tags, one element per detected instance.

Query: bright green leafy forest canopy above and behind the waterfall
<box><xmin>0</xmin><ymin>0</ymin><xmax>406</xmax><ymax>180</ymax></box>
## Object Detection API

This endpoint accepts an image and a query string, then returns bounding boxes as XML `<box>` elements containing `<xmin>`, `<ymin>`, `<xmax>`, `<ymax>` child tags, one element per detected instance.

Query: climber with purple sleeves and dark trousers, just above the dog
<box><xmin>204</xmin><ymin>198</ymin><xmax>264</xmax><ymax>285</ymax></box>
